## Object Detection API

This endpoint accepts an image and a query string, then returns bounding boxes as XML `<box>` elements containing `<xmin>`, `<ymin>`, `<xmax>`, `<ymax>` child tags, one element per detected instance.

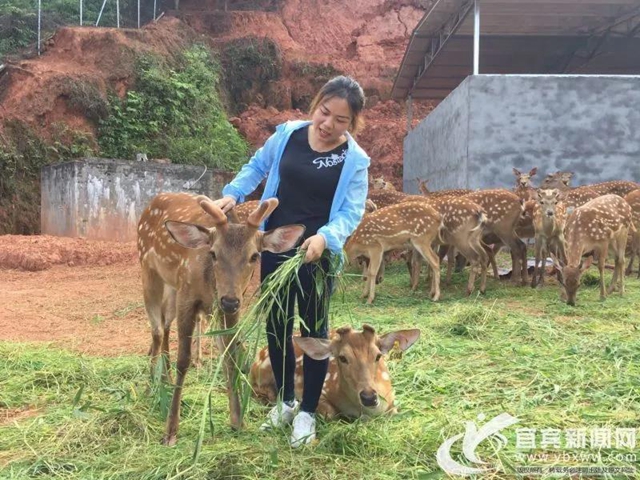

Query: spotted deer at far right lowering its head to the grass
<box><xmin>554</xmin><ymin>194</ymin><xmax>636</xmax><ymax>306</ymax></box>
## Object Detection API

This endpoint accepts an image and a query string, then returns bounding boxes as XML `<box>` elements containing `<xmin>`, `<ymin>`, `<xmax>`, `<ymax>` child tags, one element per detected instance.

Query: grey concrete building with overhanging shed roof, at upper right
<box><xmin>392</xmin><ymin>0</ymin><xmax>640</xmax><ymax>193</ymax></box>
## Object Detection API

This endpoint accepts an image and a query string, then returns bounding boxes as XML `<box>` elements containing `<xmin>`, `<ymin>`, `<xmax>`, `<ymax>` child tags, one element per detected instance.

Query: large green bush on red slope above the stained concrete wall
<box><xmin>98</xmin><ymin>46</ymin><xmax>248</xmax><ymax>170</ymax></box>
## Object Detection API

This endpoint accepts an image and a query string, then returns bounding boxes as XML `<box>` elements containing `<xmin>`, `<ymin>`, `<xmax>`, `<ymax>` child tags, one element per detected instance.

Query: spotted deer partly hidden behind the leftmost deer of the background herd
<box><xmin>405</xmin><ymin>195</ymin><xmax>489</xmax><ymax>295</ymax></box>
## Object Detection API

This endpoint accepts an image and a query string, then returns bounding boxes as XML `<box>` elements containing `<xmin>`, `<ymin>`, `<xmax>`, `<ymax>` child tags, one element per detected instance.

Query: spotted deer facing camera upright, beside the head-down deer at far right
<box><xmin>530</xmin><ymin>188</ymin><xmax>567</xmax><ymax>287</ymax></box>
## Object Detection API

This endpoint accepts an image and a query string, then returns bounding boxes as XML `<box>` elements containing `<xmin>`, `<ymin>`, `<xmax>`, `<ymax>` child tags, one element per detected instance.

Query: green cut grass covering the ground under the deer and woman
<box><xmin>0</xmin><ymin>264</ymin><xmax>640</xmax><ymax>479</ymax></box>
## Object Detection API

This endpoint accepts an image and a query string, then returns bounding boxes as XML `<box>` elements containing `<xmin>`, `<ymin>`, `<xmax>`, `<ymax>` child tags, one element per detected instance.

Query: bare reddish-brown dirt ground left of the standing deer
<box><xmin>0</xmin><ymin>236</ymin><xmax>257</xmax><ymax>356</ymax></box>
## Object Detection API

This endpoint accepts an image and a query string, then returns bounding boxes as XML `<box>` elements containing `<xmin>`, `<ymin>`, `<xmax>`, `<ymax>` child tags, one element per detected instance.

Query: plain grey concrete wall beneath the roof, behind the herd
<box><xmin>404</xmin><ymin>75</ymin><xmax>640</xmax><ymax>192</ymax></box>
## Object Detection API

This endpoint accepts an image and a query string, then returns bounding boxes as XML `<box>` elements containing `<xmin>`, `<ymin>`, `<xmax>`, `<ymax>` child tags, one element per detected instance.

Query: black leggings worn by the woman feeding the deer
<box><xmin>260</xmin><ymin>250</ymin><xmax>332</xmax><ymax>413</ymax></box>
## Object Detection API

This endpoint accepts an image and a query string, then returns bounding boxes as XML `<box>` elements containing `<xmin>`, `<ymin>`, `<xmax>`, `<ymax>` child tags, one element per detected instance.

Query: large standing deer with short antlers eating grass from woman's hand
<box><xmin>137</xmin><ymin>193</ymin><xmax>304</xmax><ymax>446</ymax></box>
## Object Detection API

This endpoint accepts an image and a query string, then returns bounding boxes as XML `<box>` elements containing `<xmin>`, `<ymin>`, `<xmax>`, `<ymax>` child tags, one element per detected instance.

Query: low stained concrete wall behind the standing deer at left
<box><xmin>41</xmin><ymin>158</ymin><xmax>233</xmax><ymax>241</ymax></box>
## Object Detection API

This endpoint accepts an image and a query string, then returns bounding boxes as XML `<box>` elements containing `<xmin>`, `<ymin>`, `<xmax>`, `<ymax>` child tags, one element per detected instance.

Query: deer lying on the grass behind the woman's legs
<box><xmin>249</xmin><ymin>324</ymin><xmax>420</xmax><ymax>419</ymax></box>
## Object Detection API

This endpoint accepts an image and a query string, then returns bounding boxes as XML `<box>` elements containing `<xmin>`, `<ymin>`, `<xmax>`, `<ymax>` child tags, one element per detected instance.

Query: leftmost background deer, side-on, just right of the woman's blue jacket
<box><xmin>344</xmin><ymin>202</ymin><xmax>443</xmax><ymax>304</ymax></box>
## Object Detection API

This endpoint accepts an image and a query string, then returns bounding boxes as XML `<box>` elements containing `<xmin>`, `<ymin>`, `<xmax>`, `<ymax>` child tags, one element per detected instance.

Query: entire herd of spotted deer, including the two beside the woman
<box><xmin>138</xmin><ymin>168</ymin><xmax>640</xmax><ymax>445</ymax></box>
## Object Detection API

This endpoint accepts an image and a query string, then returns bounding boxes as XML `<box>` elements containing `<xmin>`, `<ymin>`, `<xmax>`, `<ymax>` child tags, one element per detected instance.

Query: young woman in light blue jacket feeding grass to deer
<box><xmin>216</xmin><ymin>76</ymin><xmax>370</xmax><ymax>447</ymax></box>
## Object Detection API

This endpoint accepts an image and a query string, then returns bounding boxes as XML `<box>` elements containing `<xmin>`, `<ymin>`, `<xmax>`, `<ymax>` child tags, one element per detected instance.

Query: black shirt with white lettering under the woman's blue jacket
<box><xmin>266</xmin><ymin>126</ymin><xmax>347</xmax><ymax>239</ymax></box>
